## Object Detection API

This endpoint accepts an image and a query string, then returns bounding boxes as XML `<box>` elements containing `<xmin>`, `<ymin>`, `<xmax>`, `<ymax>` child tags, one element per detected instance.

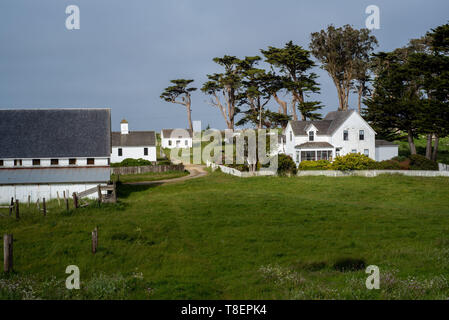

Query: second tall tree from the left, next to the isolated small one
<box><xmin>201</xmin><ymin>55</ymin><xmax>242</xmax><ymax>130</ymax></box>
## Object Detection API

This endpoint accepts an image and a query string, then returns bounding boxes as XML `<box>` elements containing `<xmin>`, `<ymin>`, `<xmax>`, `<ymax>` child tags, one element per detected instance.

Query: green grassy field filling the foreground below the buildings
<box><xmin>0</xmin><ymin>172</ymin><xmax>449</xmax><ymax>299</ymax></box>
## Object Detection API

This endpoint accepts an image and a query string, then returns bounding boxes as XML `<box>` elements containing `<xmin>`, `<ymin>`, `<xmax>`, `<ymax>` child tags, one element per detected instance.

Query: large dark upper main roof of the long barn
<box><xmin>0</xmin><ymin>109</ymin><xmax>111</xmax><ymax>158</ymax></box>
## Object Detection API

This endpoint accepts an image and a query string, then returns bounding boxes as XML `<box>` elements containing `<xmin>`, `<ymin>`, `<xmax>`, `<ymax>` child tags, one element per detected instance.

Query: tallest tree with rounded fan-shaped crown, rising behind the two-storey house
<box><xmin>310</xmin><ymin>25</ymin><xmax>377</xmax><ymax>110</ymax></box>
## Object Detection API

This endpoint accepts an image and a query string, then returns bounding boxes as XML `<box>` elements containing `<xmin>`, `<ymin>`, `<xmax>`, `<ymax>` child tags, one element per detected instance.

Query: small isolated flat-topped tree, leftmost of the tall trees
<box><xmin>161</xmin><ymin>79</ymin><xmax>197</xmax><ymax>130</ymax></box>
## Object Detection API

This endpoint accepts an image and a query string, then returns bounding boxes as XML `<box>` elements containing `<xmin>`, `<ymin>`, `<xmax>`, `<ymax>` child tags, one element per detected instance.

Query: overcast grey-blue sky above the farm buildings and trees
<box><xmin>0</xmin><ymin>0</ymin><xmax>449</xmax><ymax>130</ymax></box>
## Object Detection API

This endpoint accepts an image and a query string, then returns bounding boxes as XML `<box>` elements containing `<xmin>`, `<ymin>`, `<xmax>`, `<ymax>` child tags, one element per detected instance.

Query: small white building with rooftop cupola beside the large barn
<box><xmin>111</xmin><ymin>120</ymin><xmax>156</xmax><ymax>163</ymax></box>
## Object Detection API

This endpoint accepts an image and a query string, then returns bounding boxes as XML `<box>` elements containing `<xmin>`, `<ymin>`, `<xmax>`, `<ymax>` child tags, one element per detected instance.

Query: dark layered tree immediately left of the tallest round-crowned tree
<box><xmin>261</xmin><ymin>41</ymin><xmax>322</xmax><ymax>120</ymax></box>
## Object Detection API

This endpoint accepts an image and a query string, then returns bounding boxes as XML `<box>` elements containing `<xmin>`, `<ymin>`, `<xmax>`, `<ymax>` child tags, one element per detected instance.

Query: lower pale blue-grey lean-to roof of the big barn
<box><xmin>0</xmin><ymin>167</ymin><xmax>111</xmax><ymax>185</ymax></box>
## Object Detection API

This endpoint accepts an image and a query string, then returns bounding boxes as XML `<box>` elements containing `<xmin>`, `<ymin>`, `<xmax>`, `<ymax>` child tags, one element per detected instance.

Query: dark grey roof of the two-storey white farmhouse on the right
<box><xmin>290</xmin><ymin>110</ymin><xmax>354</xmax><ymax>136</ymax></box>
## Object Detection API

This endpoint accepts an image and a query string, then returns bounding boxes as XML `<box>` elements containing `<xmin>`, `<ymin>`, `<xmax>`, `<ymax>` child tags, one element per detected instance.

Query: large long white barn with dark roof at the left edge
<box><xmin>0</xmin><ymin>109</ymin><xmax>111</xmax><ymax>203</ymax></box>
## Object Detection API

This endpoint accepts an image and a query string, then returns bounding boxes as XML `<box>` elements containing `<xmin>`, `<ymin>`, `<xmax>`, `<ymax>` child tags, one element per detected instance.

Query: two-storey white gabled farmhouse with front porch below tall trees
<box><xmin>285</xmin><ymin>110</ymin><xmax>376</xmax><ymax>164</ymax></box>
